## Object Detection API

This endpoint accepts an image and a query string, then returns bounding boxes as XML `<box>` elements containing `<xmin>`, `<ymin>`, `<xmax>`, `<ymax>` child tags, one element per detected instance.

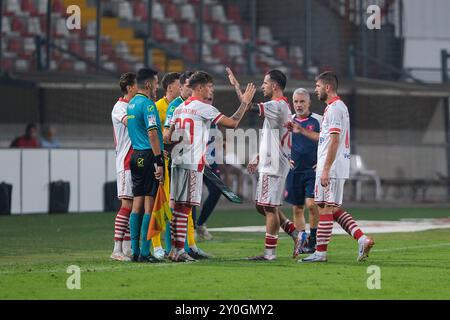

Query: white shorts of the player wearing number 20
<box><xmin>170</xmin><ymin>167</ymin><xmax>203</xmax><ymax>206</ymax></box>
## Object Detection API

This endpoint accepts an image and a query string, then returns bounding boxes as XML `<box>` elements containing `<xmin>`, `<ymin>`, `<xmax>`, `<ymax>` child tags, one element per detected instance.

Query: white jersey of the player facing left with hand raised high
<box><xmin>258</xmin><ymin>97</ymin><xmax>292</xmax><ymax>177</ymax></box>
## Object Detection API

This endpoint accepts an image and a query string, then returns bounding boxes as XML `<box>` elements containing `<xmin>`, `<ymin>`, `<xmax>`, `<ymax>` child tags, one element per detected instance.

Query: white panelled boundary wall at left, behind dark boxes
<box><xmin>0</xmin><ymin>149</ymin><xmax>116</xmax><ymax>214</ymax></box>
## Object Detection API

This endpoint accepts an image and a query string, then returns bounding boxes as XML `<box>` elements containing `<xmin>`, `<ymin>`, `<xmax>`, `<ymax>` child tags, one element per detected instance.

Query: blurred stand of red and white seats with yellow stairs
<box><xmin>1</xmin><ymin>0</ymin><xmax>303</xmax><ymax>78</ymax></box>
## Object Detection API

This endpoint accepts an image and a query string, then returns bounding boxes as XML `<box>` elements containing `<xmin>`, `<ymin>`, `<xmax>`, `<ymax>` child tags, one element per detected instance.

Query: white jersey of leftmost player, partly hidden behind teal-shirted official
<box><xmin>111</xmin><ymin>98</ymin><xmax>133</xmax><ymax>172</ymax></box>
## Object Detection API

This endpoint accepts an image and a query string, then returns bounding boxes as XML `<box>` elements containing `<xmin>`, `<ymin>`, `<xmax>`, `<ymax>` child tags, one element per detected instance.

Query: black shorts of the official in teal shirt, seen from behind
<box><xmin>130</xmin><ymin>150</ymin><xmax>159</xmax><ymax>197</ymax></box>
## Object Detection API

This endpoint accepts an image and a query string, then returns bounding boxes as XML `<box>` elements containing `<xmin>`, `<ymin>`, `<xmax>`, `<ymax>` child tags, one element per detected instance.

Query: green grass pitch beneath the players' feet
<box><xmin>0</xmin><ymin>208</ymin><xmax>450</xmax><ymax>300</ymax></box>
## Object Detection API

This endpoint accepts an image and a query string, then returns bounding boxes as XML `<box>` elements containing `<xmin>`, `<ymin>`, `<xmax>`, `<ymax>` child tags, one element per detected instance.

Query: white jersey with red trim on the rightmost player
<box><xmin>316</xmin><ymin>97</ymin><xmax>350</xmax><ymax>179</ymax></box>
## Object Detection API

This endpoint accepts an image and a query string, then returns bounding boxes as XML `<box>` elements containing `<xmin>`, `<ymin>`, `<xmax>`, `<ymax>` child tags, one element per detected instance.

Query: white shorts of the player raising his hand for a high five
<box><xmin>256</xmin><ymin>173</ymin><xmax>286</xmax><ymax>207</ymax></box>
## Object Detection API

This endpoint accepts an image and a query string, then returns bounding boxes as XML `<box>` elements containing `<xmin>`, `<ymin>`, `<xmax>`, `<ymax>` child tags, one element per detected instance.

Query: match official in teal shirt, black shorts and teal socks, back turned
<box><xmin>127</xmin><ymin>68</ymin><xmax>163</xmax><ymax>263</ymax></box>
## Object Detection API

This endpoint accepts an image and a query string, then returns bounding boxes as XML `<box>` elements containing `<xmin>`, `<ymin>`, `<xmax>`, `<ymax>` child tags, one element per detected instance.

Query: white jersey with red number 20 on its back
<box><xmin>171</xmin><ymin>97</ymin><xmax>223</xmax><ymax>172</ymax></box>
